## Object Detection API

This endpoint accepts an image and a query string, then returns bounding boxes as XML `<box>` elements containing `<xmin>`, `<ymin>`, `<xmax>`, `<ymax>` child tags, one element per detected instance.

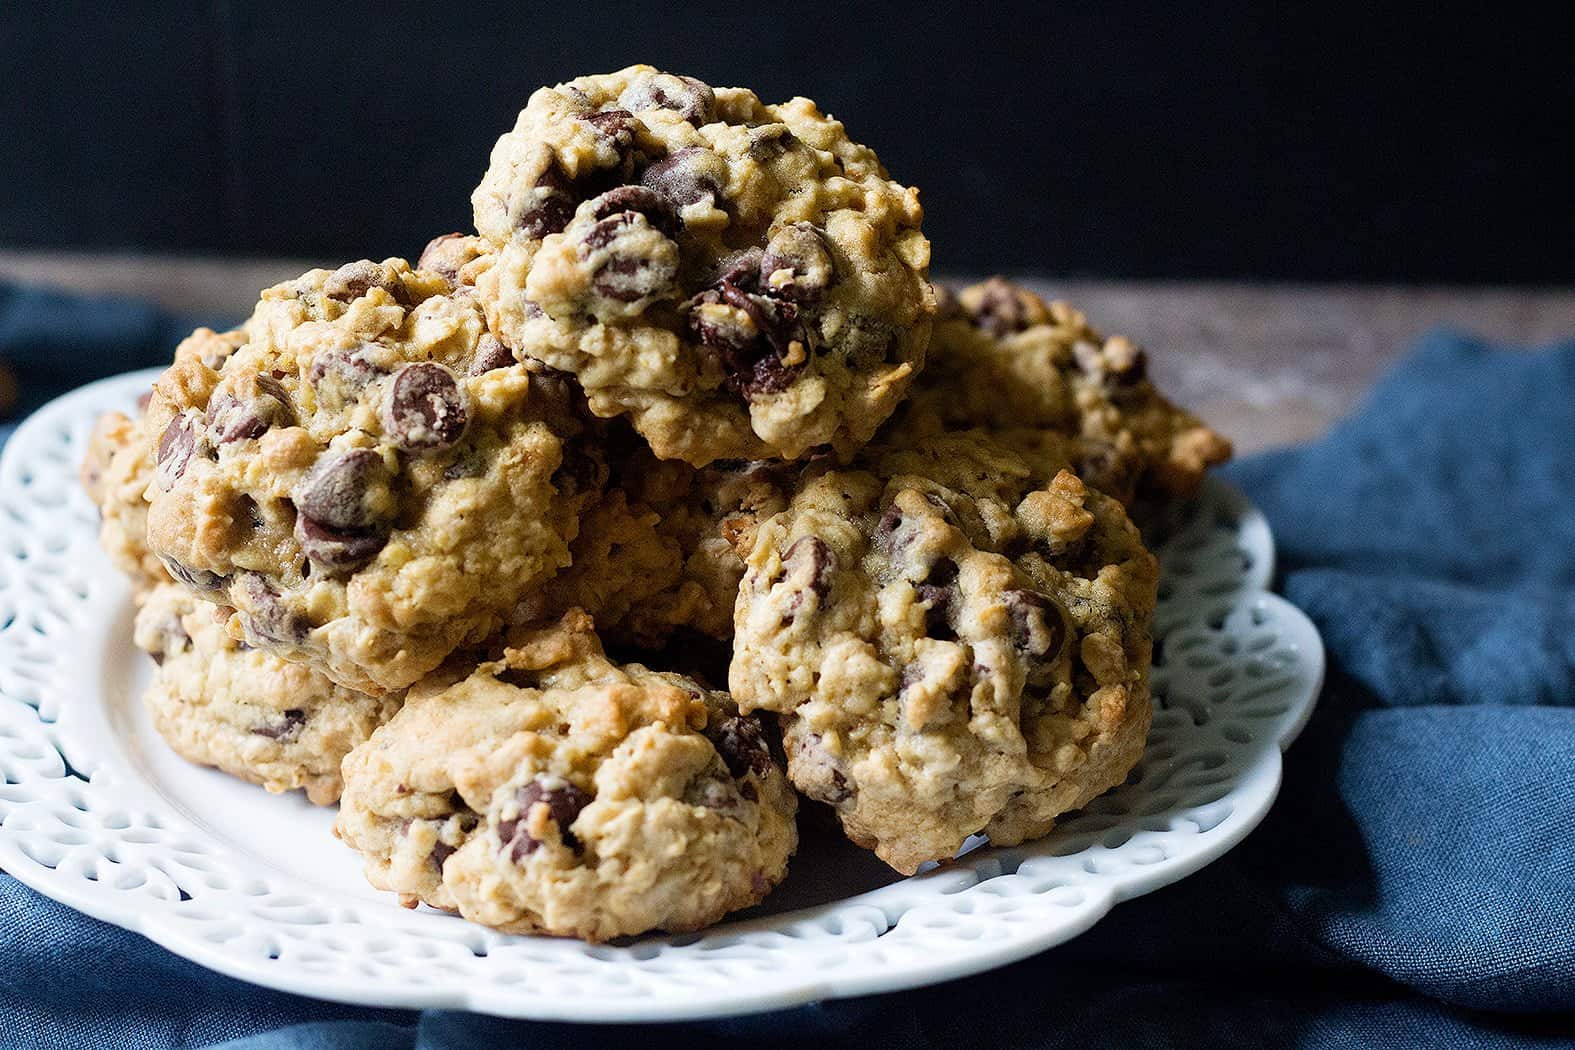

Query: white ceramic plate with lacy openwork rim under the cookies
<box><xmin>0</xmin><ymin>372</ymin><xmax>1323</xmax><ymax>1022</ymax></box>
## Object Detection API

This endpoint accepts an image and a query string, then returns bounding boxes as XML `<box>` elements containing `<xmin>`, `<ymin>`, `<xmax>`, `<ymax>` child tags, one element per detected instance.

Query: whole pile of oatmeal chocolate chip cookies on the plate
<box><xmin>74</xmin><ymin>66</ymin><xmax>1230</xmax><ymax>940</ymax></box>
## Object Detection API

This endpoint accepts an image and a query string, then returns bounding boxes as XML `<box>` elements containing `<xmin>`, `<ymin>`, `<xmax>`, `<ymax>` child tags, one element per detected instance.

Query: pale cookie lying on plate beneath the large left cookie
<box><xmin>135</xmin><ymin>582</ymin><xmax>400</xmax><ymax>806</ymax></box>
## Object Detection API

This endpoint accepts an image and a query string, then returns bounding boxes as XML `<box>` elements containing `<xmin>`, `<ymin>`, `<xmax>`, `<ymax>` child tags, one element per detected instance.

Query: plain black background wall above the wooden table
<box><xmin>0</xmin><ymin>0</ymin><xmax>1575</xmax><ymax>283</ymax></box>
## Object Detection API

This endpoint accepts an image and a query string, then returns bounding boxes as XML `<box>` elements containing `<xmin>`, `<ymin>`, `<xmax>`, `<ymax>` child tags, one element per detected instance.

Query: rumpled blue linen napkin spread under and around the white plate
<box><xmin>0</xmin><ymin>290</ymin><xmax>1575</xmax><ymax>1050</ymax></box>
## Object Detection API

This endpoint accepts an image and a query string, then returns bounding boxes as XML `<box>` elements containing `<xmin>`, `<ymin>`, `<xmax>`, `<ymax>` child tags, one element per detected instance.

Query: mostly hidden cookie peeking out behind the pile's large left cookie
<box><xmin>82</xmin><ymin>327</ymin><xmax>246</xmax><ymax>592</ymax></box>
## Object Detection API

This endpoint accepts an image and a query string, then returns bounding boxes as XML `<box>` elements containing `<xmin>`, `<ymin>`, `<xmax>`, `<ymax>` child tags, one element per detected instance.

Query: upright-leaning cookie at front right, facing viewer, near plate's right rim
<box><xmin>731</xmin><ymin>431</ymin><xmax>1158</xmax><ymax>872</ymax></box>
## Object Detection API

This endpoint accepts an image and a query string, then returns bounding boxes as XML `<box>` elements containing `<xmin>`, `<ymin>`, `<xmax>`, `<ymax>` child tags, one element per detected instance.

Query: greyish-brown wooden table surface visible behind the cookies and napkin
<box><xmin>0</xmin><ymin>252</ymin><xmax>1575</xmax><ymax>452</ymax></box>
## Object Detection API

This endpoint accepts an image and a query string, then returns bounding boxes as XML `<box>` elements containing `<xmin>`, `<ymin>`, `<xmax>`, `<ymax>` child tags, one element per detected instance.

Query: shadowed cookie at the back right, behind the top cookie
<box><xmin>902</xmin><ymin>277</ymin><xmax>1230</xmax><ymax>504</ymax></box>
